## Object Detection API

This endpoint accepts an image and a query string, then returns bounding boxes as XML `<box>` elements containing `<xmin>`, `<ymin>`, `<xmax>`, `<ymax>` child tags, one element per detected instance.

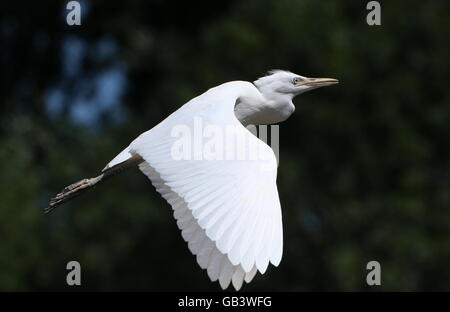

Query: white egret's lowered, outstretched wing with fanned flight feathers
<box><xmin>128</xmin><ymin>82</ymin><xmax>283</xmax><ymax>290</ymax></box>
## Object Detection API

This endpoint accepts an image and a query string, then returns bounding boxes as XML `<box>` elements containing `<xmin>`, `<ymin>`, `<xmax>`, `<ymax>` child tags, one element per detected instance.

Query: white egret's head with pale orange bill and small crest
<box><xmin>254</xmin><ymin>70</ymin><xmax>339</xmax><ymax>98</ymax></box>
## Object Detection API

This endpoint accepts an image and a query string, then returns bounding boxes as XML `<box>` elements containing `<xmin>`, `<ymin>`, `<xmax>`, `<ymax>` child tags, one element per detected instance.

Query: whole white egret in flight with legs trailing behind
<box><xmin>45</xmin><ymin>70</ymin><xmax>338</xmax><ymax>290</ymax></box>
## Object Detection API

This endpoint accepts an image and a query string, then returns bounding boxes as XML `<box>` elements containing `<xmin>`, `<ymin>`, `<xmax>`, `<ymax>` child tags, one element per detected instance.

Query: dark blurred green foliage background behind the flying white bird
<box><xmin>0</xmin><ymin>0</ymin><xmax>450</xmax><ymax>291</ymax></box>
